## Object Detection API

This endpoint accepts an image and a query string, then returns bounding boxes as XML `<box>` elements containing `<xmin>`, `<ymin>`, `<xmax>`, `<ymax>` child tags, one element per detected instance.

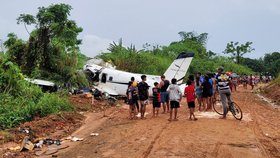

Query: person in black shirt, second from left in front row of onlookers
<box><xmin>138</xmin><ymin>75</ymin><xmax>149</xmax><ymax>119</ymax></box>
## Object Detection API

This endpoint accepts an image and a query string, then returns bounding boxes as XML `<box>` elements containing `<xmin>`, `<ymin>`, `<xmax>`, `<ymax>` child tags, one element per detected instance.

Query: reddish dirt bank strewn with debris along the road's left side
<box><xmin>0</xmin><ymin>93</ymin><xmax>118</xmax><ymax>157</ymax></box>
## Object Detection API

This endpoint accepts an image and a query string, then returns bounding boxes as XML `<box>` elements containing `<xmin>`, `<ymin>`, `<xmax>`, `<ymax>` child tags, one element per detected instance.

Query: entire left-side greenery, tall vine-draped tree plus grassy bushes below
<box><xmin>0</xmin><ymin>4</ymin><xmax>83</xmax><ymax>129</ymax></box>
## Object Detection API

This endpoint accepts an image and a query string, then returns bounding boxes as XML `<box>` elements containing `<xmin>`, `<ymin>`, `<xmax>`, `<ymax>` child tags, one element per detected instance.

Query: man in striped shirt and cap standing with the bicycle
<box><xmin>216</xmin><ymin>67</ymin><xmax>231</xmax><ymax>119</ymax></box>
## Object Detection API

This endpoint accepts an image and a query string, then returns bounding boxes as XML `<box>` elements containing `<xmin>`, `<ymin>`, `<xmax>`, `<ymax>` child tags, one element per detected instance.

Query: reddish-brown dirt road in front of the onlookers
<box><xmin>58</xmin><ymin>87</ymin><xmax>280</xmax><ymax>158</ymax></box>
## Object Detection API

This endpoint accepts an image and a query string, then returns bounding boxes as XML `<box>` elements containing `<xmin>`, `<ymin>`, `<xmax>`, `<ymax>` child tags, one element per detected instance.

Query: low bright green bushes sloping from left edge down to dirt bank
<box><xmin>0</xmin><ymin>56</ymin><xmax>74</xmax><ymax>129</ymax></box>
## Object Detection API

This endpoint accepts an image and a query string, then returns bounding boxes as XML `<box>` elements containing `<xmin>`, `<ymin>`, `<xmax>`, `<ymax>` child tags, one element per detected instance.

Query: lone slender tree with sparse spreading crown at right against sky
<box><xmin>224</xmin><ymin>41</ymin><xmax>255</xmax><ymax>64</ymax></box>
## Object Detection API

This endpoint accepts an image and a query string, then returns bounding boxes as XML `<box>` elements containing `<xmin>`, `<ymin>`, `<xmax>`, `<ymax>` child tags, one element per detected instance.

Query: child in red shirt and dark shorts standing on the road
<box><xmin>185</xmin><ymin>80</ymin><xmax>197</xmax><ymax>121</ymax></box>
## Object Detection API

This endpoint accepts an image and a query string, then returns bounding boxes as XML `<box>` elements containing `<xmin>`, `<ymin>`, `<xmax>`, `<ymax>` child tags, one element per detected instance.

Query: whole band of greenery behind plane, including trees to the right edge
<box><xmin>99</xmin><ymin>31</ymin><xmax>280</xmax><ymax>76</ymax></box>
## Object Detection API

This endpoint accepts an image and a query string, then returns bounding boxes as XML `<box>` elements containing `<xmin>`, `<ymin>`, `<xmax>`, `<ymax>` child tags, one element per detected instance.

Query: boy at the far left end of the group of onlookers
<box><xmin>126</xmin><ymin>82</ymin><xmax>137</xmax><ymax>119</ymax></box>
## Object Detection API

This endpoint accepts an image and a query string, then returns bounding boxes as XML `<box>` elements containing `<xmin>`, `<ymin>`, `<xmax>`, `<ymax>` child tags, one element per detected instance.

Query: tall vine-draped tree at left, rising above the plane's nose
<box><xmin>14</xmin><ymin>4</ymin><xmax>82</xmax><ymax>80</ymax></box>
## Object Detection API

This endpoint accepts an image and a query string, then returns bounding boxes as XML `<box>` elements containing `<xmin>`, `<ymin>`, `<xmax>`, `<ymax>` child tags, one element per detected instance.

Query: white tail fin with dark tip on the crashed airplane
<box><xmin>164</xmin><ymin>52</ymin><xmax>194</xmax><ymax>84</ymax></box>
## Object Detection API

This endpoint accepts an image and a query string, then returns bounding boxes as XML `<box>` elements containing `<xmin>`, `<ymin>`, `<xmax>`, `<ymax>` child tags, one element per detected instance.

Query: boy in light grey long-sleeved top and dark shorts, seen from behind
<box><xmin>167</xmin><ymin>78</ymin><xmax>182</xmax><ymax>121</ymax></box>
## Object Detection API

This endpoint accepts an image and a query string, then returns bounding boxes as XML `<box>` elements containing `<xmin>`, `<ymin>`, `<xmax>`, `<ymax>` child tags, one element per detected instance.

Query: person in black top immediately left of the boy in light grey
<box><xmin>159</xmin><ymin>75</ymin><xmax>170</xmax><ymax>113</ymax></box>
